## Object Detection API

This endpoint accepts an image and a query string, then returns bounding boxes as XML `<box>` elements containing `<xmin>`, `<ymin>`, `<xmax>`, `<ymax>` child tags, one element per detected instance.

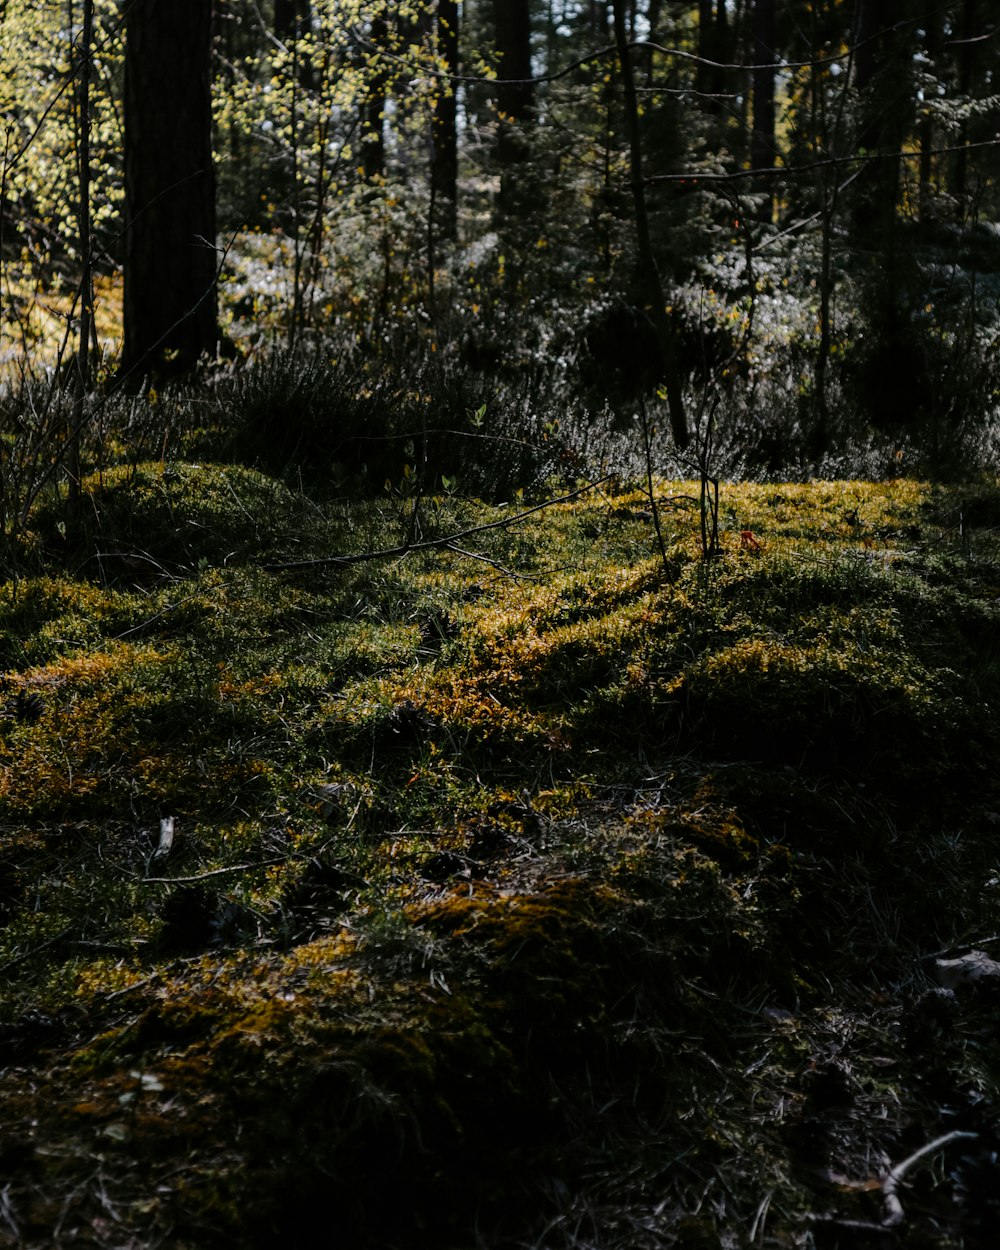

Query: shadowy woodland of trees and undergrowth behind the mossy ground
<box><xmin>0</xmin><ymin>0</ymin><xmax>1000</xmax><ymax>522</ymax></box>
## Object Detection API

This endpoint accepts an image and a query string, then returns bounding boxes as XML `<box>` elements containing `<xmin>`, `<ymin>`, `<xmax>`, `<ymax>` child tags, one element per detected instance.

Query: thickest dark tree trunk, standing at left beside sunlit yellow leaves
<box><xmin>123</xmin><ymin>0</ymin><xmax>219</xmax><ymax>376</ymax></box>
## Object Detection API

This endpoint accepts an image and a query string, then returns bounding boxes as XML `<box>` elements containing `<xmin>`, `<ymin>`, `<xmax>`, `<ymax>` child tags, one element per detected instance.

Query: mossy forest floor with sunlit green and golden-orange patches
<box><xmin>0</xmin><ymin>464</ymin><xmax>1000</xmax><ymax>1250</ymax></box>
